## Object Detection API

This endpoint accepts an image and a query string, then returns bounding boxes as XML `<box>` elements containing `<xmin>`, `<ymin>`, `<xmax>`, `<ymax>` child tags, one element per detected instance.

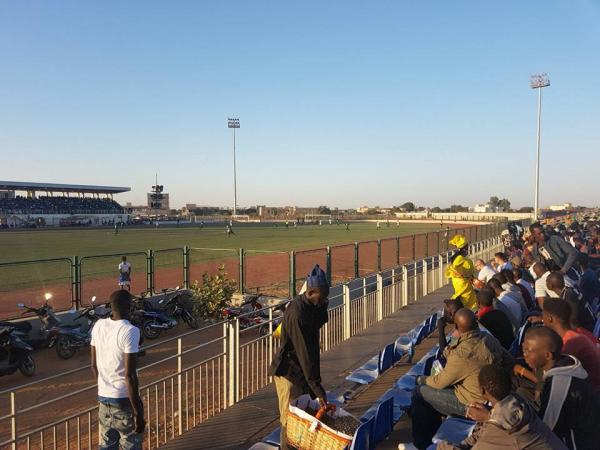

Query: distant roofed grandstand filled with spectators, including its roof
<box><xmin>0</xmin><ymin>181</ymin><xmax>131</xmax><ymax>228</ymax></box>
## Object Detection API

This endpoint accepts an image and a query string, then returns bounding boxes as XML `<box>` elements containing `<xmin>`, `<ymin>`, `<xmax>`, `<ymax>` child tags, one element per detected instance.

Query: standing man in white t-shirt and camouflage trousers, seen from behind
<box><xmin>91</xmin><ymin>290</ymin><xmax>146</xmax><ymax>450</ymax></box>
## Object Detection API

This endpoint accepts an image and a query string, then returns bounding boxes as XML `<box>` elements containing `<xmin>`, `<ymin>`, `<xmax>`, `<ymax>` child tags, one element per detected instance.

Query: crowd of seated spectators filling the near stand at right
<box><xmin>398</xmin><ymin>218</ymin><xmax>600</xmax><ymax>450</ymax></box>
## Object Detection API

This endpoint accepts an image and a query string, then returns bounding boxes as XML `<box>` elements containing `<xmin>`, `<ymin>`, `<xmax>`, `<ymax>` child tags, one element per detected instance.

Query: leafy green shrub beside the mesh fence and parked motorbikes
<box><xmin>190</xmin><ymin>265</ymin><xmax>237</xmax><ymax>318</ymax></box>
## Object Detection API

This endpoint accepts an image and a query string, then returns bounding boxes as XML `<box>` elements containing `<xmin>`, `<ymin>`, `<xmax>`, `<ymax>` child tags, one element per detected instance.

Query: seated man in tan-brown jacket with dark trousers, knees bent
<box><xmin>411</xmin><ymin>309</ymin><xmax>513</xmax><ymax>449</ymax></box>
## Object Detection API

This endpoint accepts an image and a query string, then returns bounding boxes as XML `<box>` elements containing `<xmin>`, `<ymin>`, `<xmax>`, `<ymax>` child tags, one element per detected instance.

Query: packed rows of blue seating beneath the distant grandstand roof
<box><xmin>0</xmin><ymin>196</ymin><xmax>123</xmax><ymax>214</ymax></box>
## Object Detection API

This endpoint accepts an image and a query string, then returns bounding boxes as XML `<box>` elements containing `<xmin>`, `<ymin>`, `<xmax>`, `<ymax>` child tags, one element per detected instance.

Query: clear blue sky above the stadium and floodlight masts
<box><xmin>0</xmin><ymin>0</ymin><xmax>600</xmax><ymax>207</ymax></box>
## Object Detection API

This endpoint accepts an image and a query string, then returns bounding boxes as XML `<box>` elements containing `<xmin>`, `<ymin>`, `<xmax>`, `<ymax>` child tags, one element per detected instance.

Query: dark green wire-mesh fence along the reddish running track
<box><xmin>0</xmin><ymin>223</ymin><xmax>505</xmax><ymax>319</ymax></box>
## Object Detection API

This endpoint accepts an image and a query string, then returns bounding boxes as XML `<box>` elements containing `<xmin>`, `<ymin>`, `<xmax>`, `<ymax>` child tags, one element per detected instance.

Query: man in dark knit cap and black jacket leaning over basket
<box><xmin>269</xmin><ymin>264</ymin><xmax>329</xmax><ymax>450</ymax></box>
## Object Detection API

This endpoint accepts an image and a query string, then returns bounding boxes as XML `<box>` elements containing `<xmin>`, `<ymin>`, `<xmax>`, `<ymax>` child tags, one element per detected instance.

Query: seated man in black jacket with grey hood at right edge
<box><xmin>523</xmin><ymin>327</ymin><xmax>600</xmax><ymax>450</ymax></box>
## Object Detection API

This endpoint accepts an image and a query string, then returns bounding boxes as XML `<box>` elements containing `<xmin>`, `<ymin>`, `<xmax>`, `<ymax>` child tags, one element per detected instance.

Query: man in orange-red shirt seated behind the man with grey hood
<box><xmin>543</xmin><ymin>298</ymin><xmax>600</xmax><ymax>391</ymax></box>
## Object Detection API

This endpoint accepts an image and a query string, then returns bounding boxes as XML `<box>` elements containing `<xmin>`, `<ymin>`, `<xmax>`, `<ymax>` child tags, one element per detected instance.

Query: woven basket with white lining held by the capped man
<box><xmin>286</xmin><ymin>400</ymin><xmax>352</xmax><ymax>450</ymax></box>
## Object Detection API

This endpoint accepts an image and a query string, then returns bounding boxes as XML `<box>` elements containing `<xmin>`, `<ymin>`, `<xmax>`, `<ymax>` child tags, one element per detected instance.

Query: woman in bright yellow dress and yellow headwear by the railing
<box><xmin>446</xmin><ymin>234</ymin><xmax>477</xmax><ymax>310</ymax></box>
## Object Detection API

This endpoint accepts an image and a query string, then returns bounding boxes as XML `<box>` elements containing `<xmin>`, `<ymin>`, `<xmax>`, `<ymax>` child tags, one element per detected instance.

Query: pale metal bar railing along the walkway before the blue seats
<box><xmin>0</xmin><ymin>232</ymin><xmax>502</xmax><ymax>450</ymax></box>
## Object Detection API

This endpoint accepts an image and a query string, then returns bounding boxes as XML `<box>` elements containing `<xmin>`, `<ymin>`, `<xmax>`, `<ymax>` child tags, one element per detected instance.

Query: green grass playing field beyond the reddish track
<box><xmin>0</xmin><ymin>223</ymin><xmax>440</xmax><ymax>262</ymax></box>
